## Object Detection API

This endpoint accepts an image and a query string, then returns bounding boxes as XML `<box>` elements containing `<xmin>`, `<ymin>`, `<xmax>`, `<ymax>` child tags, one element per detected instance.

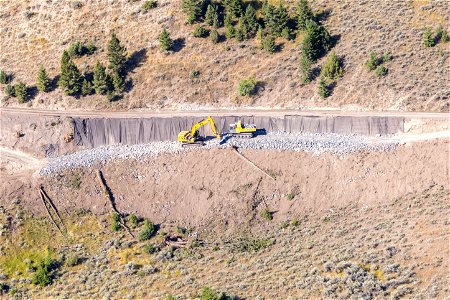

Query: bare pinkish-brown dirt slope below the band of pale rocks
<box><xmin>1</xmin><ymin>140</ymin><xmax>449</xmax><ymax>234</ymax></box>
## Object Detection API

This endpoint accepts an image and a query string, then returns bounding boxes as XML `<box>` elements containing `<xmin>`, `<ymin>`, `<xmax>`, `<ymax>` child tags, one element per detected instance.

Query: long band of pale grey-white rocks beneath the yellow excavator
<box><xmin>39</xmin><ymin>132</ymin><xmax>397</xmax><ymax>176</ymax></box>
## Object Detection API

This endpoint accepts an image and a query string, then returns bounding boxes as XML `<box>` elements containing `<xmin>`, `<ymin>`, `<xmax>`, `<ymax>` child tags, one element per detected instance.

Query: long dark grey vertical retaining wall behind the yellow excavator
<box><xmin>74</xmin><ymin>115</ymin><xmax>404</xmax><ymax>148</ymax></box>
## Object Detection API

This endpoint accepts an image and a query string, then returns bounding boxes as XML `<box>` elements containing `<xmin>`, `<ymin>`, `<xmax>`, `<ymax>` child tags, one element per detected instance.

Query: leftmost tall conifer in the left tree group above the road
<box><xmin>59</xmin><ymin>51</ymin><xmax>82</xmax><ymax>95</ymax></box>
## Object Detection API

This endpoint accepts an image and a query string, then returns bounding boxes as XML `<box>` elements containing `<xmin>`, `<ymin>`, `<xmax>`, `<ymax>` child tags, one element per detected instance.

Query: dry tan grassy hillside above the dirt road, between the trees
<box><xmin>0</xmin><ymin>0</ymin><xmax>450</xmax><ymax>111</ymax></box>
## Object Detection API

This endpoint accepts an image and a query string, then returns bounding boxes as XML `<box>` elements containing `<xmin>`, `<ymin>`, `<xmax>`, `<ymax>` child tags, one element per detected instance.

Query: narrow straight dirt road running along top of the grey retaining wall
<box><xmin>0</xmin><ymin>107</ymin><xmax>450</xmax><ymax>120</ymax></box>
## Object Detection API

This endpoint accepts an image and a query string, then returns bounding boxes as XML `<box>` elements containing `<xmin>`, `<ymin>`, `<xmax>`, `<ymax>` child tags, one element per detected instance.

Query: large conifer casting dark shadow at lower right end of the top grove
<box><xmin>302</xmin><ymin>20</ymin><xmax>330</xmax><ymax>62</ymax></box>
